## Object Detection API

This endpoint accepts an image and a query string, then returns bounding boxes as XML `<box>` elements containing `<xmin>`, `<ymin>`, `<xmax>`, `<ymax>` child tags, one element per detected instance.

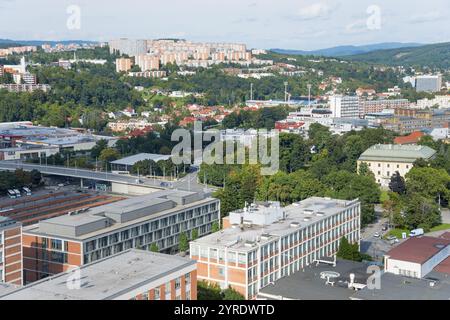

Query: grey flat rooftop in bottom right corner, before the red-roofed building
<box><xmin>352</xmin><ymin>271</ymin><xmax>450</xmax><ymax>300</ymax></box>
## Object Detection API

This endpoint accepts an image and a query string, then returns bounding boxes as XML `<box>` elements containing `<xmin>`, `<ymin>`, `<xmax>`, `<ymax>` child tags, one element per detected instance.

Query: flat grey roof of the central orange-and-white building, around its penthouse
<box><xmin>193</xmin><ymin>197</ymin><xmax>359</xmax><ymax>251</ymax></box>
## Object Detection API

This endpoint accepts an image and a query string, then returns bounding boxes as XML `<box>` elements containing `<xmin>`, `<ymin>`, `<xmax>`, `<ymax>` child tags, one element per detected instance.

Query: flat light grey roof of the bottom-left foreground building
<box><xmin>0</xmin><ymin>249</ymin><xmax>195</xmax><ymax>300</ymax></box>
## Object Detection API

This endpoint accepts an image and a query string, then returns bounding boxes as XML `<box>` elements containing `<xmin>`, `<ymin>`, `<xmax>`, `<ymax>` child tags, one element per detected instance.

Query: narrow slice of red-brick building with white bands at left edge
<box><xmin>0</xmin><ymin>216</ymin><xmax>22</xmax><ymax>285</ymax></box>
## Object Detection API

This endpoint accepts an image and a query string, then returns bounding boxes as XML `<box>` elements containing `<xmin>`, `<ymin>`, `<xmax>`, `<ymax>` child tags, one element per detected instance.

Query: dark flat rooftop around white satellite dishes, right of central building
<box><xmin>260</xmin><ymin>259</ymin><xmax>370</xmax><ymax>300</ymax></box>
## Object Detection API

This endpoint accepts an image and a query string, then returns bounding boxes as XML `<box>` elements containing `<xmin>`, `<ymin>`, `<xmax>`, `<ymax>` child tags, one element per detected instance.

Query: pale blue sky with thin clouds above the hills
<box><xmin>0</xmin><ymin>0</ymin><xmax>450</xmax><ymax>50</ymax></box>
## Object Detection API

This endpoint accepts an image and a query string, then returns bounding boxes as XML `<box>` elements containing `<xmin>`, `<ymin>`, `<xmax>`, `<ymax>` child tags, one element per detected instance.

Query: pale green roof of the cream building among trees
<box><xmin>359</xmin><ymin>144</ymin><xmax>436</xmax><ymax>163</ymax></box>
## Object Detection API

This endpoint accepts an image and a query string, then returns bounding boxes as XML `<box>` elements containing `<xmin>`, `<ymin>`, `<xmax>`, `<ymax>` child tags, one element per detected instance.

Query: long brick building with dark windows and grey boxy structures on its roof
<box><xmin>23</xmin><ymin>190</ymin><xmax>220</xmax><ymax>283</ymax></box>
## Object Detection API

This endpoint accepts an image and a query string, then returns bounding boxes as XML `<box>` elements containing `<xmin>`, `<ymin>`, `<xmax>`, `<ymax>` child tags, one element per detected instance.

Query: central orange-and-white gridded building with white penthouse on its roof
<box><xmin>190</xmin><ymin>197</ymin><xmax>361</xmax><ymax>299</ymax></box>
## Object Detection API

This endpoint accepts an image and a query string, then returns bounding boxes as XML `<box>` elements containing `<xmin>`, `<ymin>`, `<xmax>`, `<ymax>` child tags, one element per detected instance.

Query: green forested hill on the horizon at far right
<box><xmin>345</xmin><ymin>42</ymin><xmax>450</xmax><ymax>69</ymax></box>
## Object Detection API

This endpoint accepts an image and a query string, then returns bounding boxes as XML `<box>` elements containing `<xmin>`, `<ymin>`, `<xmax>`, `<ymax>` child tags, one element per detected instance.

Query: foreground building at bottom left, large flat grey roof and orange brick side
<box><xmin>0</xmin><ymin>249</ymin><xmax>197</xmax><ymax>300</ymax></box>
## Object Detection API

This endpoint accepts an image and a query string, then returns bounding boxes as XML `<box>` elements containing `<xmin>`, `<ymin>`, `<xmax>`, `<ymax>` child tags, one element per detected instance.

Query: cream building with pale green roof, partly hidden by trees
<box><xmin>357</xmin><ymin>144</ymin><xmax>436</xmax><ymax>188</ymax></box>
